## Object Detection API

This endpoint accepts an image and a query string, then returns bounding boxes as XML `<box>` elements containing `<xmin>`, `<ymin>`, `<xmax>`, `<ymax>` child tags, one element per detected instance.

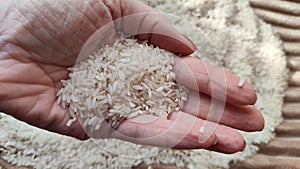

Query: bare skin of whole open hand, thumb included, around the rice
<box><xmin>0</xmin><ymin>0</ymin><xmax>264</xmax><ymax>153</ymax></box>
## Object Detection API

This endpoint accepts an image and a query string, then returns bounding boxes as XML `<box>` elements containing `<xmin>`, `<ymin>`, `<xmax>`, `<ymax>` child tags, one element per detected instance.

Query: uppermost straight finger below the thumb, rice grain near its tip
<box><xmin>174</xmin><ymin>56</ymin><xmax>256</xmax><ymax>105</ymax></box>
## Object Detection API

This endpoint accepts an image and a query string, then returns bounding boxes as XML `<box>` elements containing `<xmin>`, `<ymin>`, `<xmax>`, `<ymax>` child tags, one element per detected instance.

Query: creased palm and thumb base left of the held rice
<box><xmin>0</xmin><ymin>1</ymin><xmax>117</xmax><ymax>139</ymax></box>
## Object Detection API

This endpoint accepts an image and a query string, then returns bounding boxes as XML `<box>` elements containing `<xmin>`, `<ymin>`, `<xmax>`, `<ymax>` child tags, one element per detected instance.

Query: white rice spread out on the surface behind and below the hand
<box><xmin>0</xmin><ymin>0</ymin><xmax>286</xmax><ymax>169</ymax></box>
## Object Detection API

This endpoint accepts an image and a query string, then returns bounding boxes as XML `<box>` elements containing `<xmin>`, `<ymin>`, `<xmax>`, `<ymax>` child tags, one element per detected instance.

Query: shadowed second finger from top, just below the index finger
<box><xmin>183</xmin><ymin>91</ymin><xmax>264</xmax><ymax>132</ymax></box>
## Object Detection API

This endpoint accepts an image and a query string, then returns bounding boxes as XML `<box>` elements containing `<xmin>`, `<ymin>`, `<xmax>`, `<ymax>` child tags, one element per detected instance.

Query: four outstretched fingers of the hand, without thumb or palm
<box><xmin>112</xmin><ymin>56</ymin><xmax>264</xmax><ymax>153</ymax></box>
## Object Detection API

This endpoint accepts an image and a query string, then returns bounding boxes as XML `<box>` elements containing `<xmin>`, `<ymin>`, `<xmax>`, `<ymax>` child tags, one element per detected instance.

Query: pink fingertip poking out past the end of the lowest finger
<box><xmin>208</xmin><ymin>126</ymin><xmax>246</xmax><ymax>154</ymax></box>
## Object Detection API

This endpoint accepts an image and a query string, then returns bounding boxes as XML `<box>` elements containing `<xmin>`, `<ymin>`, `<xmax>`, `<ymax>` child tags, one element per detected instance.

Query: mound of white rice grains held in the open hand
<box><xmin>57</xmin><ymin>39</ymin><xmax>187</xmax><ymax>135</ymax></box>
